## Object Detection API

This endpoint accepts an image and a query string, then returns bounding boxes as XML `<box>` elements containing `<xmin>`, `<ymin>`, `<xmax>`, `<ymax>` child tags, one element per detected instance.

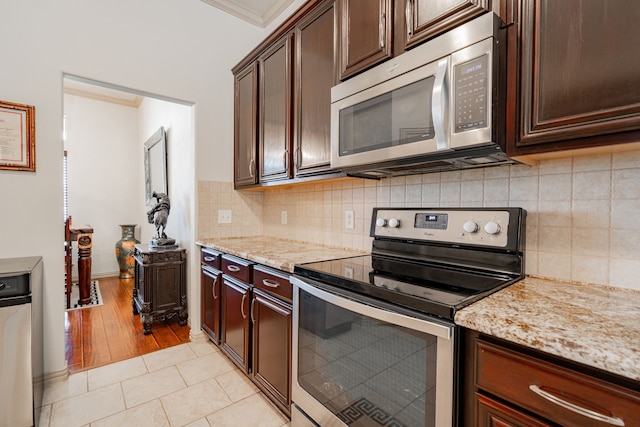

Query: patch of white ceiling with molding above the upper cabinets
<box><xmin>202</xmin><ymin>0</ymin><xmax>293</xmax><ymax>28</ymax></box>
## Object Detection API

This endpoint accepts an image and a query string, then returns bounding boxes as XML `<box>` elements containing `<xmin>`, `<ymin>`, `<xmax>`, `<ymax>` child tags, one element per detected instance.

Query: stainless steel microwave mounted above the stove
<box><xmin>331</xmin><ymin>13</ymin><xmax>515</xmax><ymax>178</ymax></box>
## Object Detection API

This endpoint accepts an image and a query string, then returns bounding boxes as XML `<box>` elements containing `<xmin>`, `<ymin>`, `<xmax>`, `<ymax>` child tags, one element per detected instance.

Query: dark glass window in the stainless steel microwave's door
<box><xmin>339</xmin><ymin>77</ymin><xmax>435</xmax><ymax>156</ymax></box>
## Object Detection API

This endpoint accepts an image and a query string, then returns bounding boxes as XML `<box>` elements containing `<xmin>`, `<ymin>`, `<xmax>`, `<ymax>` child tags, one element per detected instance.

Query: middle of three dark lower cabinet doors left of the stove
<box><xmin>221</xmin><ymin>276</ymin><xmax>250</xmax><ymax>372</ymax></box>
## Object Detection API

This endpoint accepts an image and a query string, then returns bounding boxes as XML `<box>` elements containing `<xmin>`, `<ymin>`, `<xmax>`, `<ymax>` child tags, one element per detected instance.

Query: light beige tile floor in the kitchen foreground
<box><xmin>39</xmin><ymin>341</ymin><xmax>289</xmax><ymax>427</ymax></box>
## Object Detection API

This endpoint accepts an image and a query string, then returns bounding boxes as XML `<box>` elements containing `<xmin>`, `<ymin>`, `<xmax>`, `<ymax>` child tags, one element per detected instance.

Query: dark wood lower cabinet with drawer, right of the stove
<box><xmin>464</xmin><ymin>333</ymin><xmax>640</xmax><ymax>427</ymax></box>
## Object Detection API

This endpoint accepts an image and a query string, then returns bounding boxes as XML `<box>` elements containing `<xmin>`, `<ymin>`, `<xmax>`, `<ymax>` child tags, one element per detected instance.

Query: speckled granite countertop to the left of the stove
<box><xmin>196</xmin><ymin>236</ymin><xmax>369</xmax><ymax>273</ymax></box>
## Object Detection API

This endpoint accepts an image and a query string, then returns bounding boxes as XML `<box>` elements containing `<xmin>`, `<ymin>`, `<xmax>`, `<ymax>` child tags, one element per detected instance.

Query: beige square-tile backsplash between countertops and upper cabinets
<box><xmin>198</xmin><ymin>151</ymin><xmax>640</xmax><ymax>290</ymax></box>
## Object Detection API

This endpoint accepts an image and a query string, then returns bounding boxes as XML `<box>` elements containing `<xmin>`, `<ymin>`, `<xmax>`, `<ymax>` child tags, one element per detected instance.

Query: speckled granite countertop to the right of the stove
<box><xmin>455</xmin><ymin>277</ymin><xmax>640</xmax><ymax>381</ymax></box>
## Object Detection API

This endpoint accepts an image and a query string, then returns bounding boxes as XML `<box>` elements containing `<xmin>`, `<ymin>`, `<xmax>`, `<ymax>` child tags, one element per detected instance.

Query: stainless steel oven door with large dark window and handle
<box><xmin>291</xmin><ymin>276</ymin><xmax>454</xmax><ymax>427</ymax></box>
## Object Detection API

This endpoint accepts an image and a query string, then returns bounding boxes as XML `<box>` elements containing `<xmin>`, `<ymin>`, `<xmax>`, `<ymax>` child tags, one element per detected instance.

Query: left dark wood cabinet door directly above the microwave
<box><xmin>338</xmin><ymin>0</ymin><xmax>393</xmax><ymax>80</ymax></box>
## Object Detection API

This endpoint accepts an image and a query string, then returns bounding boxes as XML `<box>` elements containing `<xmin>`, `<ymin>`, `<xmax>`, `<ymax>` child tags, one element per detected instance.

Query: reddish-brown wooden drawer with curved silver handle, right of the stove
<box><xmin>475</xmin><ymin>340</ymin><xmax>640</xmax><ymax>427</ymax></box>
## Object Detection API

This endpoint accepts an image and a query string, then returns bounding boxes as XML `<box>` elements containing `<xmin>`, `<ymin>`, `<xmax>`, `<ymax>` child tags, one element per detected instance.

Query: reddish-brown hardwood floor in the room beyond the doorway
<box><xmin>64</xmin><ymin>276</ymin><xmax>190</xmax><ymax>372</ymax></box>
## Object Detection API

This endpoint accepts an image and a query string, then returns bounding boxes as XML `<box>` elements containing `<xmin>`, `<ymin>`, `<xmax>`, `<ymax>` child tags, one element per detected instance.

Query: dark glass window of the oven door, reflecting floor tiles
<box><xmin>297</xmin><ymin>290</ymin><xmax>437</xmax><ymax>427</ymax></box>
